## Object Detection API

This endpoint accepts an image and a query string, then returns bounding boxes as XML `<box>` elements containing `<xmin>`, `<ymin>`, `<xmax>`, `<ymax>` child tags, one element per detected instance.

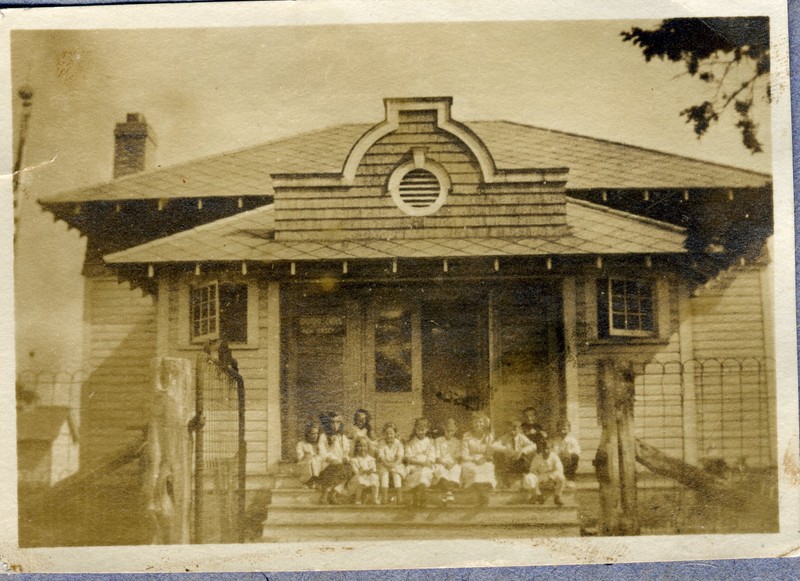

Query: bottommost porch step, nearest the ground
<box><xmin>261</xmin><ymin>520</ymin><xmax>581</xmax><ymax>543</ymax></box>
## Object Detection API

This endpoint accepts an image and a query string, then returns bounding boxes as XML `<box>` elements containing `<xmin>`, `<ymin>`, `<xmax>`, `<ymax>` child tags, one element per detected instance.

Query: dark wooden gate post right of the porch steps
<box><xmin>595</xmin><ymin>359</ymin><xmax>640</xmax><ymax>535</ymax></box>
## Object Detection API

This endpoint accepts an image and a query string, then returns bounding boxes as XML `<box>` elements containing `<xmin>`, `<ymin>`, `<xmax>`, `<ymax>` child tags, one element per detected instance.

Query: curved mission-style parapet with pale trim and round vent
<box><xmin>272</xmin><ymin>97</ymin><xmax>568</xmax><ymax>240</ymax></box>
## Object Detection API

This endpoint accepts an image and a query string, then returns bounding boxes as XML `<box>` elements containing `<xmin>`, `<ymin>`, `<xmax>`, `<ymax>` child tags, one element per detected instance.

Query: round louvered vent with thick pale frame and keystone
<box><xmin>388</xmin><ymin>155</ymin><xmax>450</xmax><ymax>216</ymax></box>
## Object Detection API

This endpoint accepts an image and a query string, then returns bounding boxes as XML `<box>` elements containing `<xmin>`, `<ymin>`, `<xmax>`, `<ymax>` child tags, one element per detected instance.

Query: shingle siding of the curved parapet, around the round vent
<box><xmin>275</xmin><ymin>111</ymin><xmax>567</xmax><ymax>240</ymax></box>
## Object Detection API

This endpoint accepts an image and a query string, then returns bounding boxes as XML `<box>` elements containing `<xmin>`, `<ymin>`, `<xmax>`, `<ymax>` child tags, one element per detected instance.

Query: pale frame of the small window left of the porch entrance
<box><xmin>178</xmin><ymin>276</ymin><xmax>259</xmax><ymax>350</ymax></box>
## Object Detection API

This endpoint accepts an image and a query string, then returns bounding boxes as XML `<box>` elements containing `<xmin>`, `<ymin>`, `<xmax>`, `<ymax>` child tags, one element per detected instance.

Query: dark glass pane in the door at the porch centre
<box><xmin>375</xmin><ymin>308</ymin><xmax>412</xmax><ymax>393</ymax></box>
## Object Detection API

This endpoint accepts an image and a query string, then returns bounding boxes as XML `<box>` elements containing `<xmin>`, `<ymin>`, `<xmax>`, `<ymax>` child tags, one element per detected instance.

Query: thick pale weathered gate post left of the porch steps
<box><xmin>144</xmin><ymin>357</ymin><xmax>194</xmax><ymax>544</ymax></box>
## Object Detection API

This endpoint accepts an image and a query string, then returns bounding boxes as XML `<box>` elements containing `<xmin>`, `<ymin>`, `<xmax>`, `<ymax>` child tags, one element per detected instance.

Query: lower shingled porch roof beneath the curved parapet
<box><xmin>105</xmin><ymin>200</ymin><xmax>686</xmax><ymax>264</ymax></box>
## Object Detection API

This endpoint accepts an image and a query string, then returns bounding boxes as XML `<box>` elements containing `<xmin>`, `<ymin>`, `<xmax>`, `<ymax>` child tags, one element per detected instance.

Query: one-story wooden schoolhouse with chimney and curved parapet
<box><xmin>42</xmin><ymin>97</ymin><xmax>775</xmax><ymax>524</ymax></box>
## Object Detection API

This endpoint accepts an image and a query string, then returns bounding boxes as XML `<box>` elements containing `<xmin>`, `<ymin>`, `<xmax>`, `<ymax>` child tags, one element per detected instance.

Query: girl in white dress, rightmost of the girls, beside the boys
<box><xmin>461</xmin><ymin>413</ymin><xmax>497</xmax><ymax>506</ymax></box>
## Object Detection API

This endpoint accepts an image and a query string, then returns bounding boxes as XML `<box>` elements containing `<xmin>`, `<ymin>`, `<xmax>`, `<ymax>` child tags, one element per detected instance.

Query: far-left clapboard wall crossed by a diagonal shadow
<box><xmin>81</xmin><ymin>277</ymin><xmax>156</xmax><ymax>466</ymax></box>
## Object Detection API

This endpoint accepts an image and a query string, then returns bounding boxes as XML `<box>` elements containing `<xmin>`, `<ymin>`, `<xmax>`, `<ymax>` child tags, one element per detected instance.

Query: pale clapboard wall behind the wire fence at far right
<box><xmin>690</xmin><ymin>263</ymin><xmax>774</xmax><ymax>465</ymax></box>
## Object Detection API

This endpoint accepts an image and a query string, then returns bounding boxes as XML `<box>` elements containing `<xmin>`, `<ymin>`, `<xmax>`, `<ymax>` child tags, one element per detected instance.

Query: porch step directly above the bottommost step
<box><xmin>264</xmin><ymin>505</ymin><xmax>578</xmax><ymax>528</ymax></box>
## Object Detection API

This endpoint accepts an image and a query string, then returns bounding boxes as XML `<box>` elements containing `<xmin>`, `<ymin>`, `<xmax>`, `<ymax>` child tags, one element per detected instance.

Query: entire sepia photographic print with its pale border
<box><xmin>6</xmin><ymin>2</ymin><xmax>800</xmax><ymax>570</ymax></box>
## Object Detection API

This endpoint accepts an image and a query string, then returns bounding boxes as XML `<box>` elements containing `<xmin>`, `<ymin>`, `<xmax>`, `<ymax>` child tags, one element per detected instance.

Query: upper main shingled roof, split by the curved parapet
<box><xmin>42</xmin><ymin>121</ymin><xmax>771</xmax><ymax>205</ymax></box>
